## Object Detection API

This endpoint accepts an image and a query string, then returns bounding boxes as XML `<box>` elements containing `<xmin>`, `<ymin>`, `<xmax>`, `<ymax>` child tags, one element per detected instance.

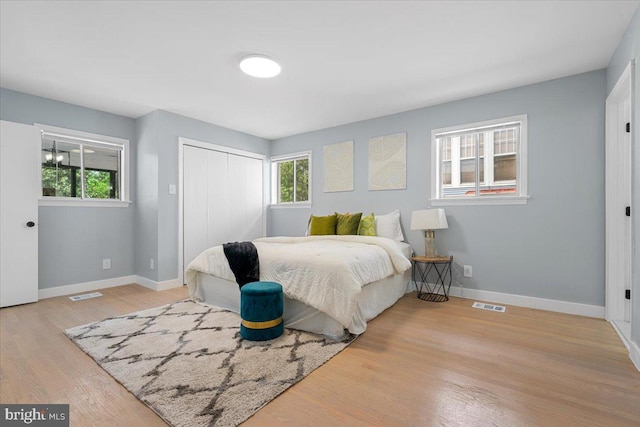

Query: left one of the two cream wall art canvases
<box><xmin>324</xmin><ymin>141</ymin><xmax>353</xmax><ymax>193</ymax></box>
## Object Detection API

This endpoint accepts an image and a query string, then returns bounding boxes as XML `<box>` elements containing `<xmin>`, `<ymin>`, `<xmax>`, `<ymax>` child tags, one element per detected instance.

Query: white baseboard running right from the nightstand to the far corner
<box><xmin>450</xmin><ymin>286</ymin><xmax>604</xmax><ymax>319</ymax></box>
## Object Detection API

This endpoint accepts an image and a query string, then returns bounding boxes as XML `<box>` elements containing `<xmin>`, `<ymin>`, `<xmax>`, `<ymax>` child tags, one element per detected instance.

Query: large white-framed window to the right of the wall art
<box><xmin>431</xmin><ymin>115</ymin><xmax>528</xmax><ymax>206</ymax></box>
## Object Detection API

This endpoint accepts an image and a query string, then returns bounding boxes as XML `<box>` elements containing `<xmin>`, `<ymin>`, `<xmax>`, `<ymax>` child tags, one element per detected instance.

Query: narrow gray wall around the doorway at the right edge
<box><xmin>607</xmin><ymin>9</ymin><xmax>640</xmax><ymax>344</ymax></box>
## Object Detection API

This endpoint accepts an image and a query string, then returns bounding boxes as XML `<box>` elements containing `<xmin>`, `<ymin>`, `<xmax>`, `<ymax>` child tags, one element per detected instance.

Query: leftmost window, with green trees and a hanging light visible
<box><xmin>40</xmin><ymin>126</ymin><xmax>129</xmax><ymax>206</ymax></box>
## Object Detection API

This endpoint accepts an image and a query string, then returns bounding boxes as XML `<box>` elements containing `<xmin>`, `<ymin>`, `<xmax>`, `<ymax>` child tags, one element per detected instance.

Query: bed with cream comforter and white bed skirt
<box><xmin>185</xmin><ymin>235</ymin><xmax>412</xmax><ymax>338</ymax></box>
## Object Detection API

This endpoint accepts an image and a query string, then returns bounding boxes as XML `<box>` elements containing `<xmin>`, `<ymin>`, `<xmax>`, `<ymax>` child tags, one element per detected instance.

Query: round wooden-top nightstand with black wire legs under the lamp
<box><xmin>411</xmin><ymin>255</ymin><xmax>453</xmax><ymax>302</ymax></box>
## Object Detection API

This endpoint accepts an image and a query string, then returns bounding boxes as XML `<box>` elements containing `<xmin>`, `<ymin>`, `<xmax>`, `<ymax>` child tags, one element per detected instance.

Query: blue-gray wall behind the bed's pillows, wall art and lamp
<box><xmin>270</xmin><ymin>70</ymin><xmax>606</xmax><ymax>306</ymax></box>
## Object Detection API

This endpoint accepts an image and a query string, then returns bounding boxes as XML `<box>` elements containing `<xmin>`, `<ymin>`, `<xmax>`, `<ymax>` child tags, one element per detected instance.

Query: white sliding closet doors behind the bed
<box><xmin>183</xmin><ymin>145</ymin><xmax>264</xmax><ymax>268</ymax></box>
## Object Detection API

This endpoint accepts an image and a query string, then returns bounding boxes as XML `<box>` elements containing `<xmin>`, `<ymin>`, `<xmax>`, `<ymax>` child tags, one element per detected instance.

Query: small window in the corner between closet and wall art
<box><xmin>271</xmin><ymin>151</ymin><xmax>311</xmax><ymax>206</ymax></box>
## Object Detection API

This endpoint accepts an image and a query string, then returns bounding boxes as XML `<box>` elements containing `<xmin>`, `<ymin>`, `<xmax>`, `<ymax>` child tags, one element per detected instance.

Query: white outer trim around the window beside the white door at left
<box><xmin>34</xmin><ymin>123</ymin><xmax>131</xmax><ymax>207</ymax></box>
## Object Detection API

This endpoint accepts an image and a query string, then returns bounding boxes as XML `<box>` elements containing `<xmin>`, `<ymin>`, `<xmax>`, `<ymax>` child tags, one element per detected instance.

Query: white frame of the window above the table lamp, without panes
<box><xmin>429</xmin><ymin>114</ymin><xmax>529</xmax><ymax>206</ymax></box>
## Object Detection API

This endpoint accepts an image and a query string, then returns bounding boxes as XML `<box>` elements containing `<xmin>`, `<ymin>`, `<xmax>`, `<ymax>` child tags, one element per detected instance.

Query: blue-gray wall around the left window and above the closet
<box><xmin>0</xmin><ymin>88</ymin><xmax>269</xmax><ymax>289</ymax></box>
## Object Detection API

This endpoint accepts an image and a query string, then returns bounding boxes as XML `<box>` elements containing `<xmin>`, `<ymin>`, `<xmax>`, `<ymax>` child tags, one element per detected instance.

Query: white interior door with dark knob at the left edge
<box><xmin>0</xmin><ymin>121</ymin><xmax>40</xmax><ymax>307</ymax></box>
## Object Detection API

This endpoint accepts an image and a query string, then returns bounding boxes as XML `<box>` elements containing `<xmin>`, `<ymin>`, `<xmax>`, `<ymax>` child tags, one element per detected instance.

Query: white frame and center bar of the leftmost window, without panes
<box><xmin>34</xmin><ymin>123</ymin><xmax>131</xmax><ymax>207</ymax></box>
